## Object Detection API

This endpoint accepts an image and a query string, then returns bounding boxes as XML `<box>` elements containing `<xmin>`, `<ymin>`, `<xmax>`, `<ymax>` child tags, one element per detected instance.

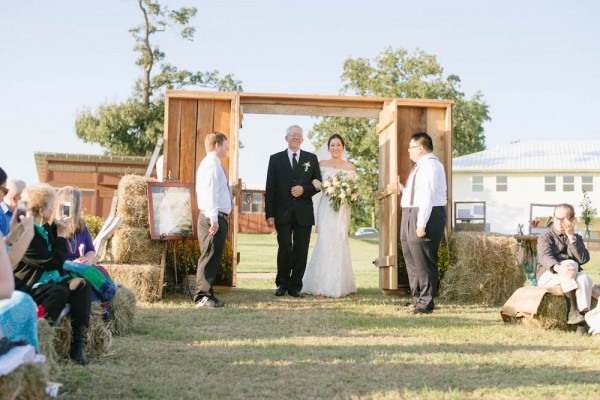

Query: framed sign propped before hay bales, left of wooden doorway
<box><xmin>148</xmin><ymin>182</ymin><xmax>198</xmax><ymax>240</ymax></box>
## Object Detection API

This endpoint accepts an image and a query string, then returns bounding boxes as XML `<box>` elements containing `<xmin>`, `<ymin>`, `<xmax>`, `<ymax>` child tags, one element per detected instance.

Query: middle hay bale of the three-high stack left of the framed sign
<box><xmin>111</xmin><ymin>226</ymin><xmax>163</xmax><ymax>266</ymax></box>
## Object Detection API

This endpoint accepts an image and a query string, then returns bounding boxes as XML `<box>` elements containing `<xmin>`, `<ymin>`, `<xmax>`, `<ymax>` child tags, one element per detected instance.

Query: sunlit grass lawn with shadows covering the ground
<box><xmin>55</xmin><ymin>234</ymin><xmax>600</xmax><ymax>399</ymax></box>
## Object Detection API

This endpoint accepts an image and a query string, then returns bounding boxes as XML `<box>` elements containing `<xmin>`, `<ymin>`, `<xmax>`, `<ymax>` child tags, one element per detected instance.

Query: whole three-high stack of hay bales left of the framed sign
<box><xmin>102</xmin><ymin>175</ymin><xmax>163</xmax><ymax>302</ymax></box>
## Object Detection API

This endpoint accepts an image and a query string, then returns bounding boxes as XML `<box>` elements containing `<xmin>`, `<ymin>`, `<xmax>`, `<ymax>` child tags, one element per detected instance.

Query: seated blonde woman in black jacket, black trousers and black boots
<box><xmin>14</xmin><ymin>183</ymin><xmax>91</xmax><ymax>365</ymax></box>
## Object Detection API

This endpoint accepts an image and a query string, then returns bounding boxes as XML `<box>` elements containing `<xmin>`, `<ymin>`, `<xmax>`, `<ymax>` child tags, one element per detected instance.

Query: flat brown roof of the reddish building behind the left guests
<box><xmin>34</xmin><ymin>152</ymin><xmax>151</xmax><ymax>182</ymax></box>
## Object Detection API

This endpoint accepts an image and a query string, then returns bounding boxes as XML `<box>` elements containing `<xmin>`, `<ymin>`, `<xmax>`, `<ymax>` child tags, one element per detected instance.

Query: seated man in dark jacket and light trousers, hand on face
<box><xmin>537</xmin><ymin>204</ymin><xmax>592</xmax><ymax>325</ymax></box>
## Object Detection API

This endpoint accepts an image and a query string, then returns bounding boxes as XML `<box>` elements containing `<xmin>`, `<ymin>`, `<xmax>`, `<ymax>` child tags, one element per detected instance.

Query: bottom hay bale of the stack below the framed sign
<box><xmin>103</xmin><ymin>264</ymin><xmax>163</xmax><ymax>302</ymax></box>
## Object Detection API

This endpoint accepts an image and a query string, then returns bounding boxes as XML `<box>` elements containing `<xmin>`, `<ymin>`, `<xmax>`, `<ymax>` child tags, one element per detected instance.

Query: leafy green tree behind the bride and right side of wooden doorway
<box><xmin>308</xmin><ymin>47</ymin><xmax>490</xmax><ymax>226</ymax></box>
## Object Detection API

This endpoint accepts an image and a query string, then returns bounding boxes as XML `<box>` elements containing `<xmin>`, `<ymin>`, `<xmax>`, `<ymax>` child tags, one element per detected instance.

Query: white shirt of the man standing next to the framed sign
<box><xmin>196</xmin><ymin>152</ymin><xmax>231</xmax><ymax>222</ymax></box>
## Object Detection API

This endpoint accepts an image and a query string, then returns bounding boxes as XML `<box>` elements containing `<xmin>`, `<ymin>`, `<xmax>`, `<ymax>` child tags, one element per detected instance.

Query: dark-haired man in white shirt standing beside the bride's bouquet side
<box><xmin>399</xmin><ymin>132</ymin><xmax>448</xmax><ymax>314</ymax></box>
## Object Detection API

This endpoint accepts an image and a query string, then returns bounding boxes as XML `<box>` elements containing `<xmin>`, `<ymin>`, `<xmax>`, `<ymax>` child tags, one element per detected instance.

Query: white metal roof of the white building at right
<box><xmin>452</xmin><ymin>140</ymin><xmax>600</xmax><ymax>172</ymax></box>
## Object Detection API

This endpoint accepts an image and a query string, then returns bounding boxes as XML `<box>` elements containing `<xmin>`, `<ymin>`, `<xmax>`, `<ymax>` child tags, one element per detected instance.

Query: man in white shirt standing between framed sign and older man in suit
<box><xmin>194</xmin><ymin>132</ymin><xmax>232</xmax><ymax>308</ymax></box>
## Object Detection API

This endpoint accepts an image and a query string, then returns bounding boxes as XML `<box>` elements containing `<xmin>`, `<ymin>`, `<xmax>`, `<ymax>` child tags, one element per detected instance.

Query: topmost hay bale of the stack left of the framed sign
<box><xmin>116</xmin><ymin>175</ymin><xmax>156</xmax><ymax>228</ymax></box>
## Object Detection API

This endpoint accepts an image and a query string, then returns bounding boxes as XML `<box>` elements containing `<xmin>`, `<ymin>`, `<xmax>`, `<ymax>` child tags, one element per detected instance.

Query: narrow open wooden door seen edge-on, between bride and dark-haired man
<box><xmin>375</xmin><ymin>100</ymin><xmax>398</xmax><ymax>290</ymax></box>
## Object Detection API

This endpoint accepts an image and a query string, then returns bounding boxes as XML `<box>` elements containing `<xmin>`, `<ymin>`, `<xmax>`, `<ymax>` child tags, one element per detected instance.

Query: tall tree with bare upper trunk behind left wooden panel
<box><xmin>75</xmin><ymin>0</ymin><xmax>242</xmax><ymax>156</ymax></box>
